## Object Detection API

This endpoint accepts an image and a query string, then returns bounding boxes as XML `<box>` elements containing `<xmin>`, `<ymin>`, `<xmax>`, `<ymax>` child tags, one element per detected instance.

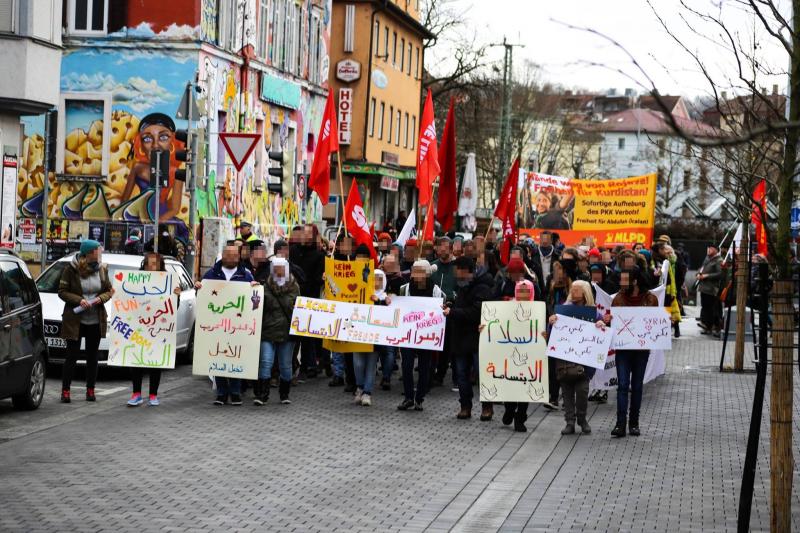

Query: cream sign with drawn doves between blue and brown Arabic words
<box><xmin>478</xmin><ymin>301</ymin><xmax>548</xmax><ymax>402</ymax></box>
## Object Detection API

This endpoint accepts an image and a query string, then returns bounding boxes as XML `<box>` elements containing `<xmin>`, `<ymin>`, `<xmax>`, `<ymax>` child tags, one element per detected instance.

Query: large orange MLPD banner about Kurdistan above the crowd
<box><xmin>519</xmin><ymin>172</ymin><xmax>656</xmax><ymax>246</ymax></box>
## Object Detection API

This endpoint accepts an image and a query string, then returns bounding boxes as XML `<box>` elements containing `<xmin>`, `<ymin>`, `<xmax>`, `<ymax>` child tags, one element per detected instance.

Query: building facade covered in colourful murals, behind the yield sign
<box><xmin>18</xmin><ymin>0</ymin><xmax>331</xmax><ymax>260</ymax></box>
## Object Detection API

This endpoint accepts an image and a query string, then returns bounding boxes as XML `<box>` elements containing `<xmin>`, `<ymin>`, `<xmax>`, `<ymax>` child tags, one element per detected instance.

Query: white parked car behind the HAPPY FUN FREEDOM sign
<box><xmin>36</xmin><ymin>253</ymin><xmax>195</xmax><ymax>364</ymax></box>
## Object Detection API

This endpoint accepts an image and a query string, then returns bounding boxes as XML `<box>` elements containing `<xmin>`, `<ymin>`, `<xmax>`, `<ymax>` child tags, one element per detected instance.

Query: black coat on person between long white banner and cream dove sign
<box><xmin>447</xmin><ymin>271</ymin><xmax>494</xmax><ymax>357</ymax></box>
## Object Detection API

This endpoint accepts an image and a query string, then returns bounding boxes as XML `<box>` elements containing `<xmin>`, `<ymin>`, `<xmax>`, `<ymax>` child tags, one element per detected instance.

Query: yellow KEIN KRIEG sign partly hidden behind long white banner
<box><xmin>322</xmin><ymin>257</ymin><xmax>375</xmax><ymax>353</ymax></box>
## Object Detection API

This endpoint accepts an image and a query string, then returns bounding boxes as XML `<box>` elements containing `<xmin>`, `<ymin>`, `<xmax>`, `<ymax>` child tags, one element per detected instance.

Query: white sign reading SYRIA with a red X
<box><xmin>611</xmin><ymin>307</ymin><xmax>672</xmax><ymax>350</ymax></box>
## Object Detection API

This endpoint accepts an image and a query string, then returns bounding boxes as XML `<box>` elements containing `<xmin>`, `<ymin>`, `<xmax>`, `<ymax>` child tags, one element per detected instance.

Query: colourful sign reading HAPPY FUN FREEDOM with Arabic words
<box><xmin>108</xmin><ymin>270</ymin><xmax>178</xmax><ymax>368</ymax></box>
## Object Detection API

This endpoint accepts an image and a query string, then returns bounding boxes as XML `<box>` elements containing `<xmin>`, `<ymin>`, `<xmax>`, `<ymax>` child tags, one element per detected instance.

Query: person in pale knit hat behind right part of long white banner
<box><xmin>397</xmin><ymin>259</ymin><xmax>444</xmax><ymax>411</ymax></box>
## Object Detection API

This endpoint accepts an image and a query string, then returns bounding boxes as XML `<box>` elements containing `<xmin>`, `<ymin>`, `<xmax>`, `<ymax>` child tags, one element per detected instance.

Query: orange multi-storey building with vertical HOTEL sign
<box><xmin>325</xmin><ymin>0</ymin><xmax>428</xmax><ymax>227</ymax></box>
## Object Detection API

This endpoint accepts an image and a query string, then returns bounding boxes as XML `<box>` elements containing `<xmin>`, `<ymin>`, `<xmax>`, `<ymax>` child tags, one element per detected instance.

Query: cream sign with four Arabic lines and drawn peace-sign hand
<box><xmin>192</xmin><ymin>280</ymin><xmax>264</xmax><ymax>379</ymax></box>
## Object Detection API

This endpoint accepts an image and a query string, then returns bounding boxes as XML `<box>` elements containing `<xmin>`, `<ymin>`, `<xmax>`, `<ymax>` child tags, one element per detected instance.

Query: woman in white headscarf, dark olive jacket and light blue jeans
<box><xmin>253</xmin><ymin>256</ymin><xmax>300</xmax><ymax>405</ymax></box>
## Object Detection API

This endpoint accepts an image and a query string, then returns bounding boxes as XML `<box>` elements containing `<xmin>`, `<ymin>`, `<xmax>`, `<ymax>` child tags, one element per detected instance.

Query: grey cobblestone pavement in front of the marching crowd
<box><xmin>0</xmin><ymin>308</ymin><xmax>800</xmax><ymax>532</ymax></box>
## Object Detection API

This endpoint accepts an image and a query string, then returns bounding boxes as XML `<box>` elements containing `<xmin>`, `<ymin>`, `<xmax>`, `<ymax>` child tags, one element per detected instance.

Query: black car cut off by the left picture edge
<box><xmin>0</xmin><ymin>249</ymin><xmax>47</xmax><ymax>409</ymax></box>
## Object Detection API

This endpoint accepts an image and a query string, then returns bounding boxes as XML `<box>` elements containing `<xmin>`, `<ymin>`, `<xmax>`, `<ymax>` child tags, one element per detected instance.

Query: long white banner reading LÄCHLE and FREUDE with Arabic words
<box><xmin>289</xmin><ymin>296</ymin><xmax>445</xmax><ymax>351</ymax></box>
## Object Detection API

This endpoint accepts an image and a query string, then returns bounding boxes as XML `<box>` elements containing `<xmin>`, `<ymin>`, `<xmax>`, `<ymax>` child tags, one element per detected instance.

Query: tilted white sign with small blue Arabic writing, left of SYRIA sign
<box><xmin>547</xmin><ymin>315</ymin><xmax>614</xmax><ymax>369</ymax></box>
